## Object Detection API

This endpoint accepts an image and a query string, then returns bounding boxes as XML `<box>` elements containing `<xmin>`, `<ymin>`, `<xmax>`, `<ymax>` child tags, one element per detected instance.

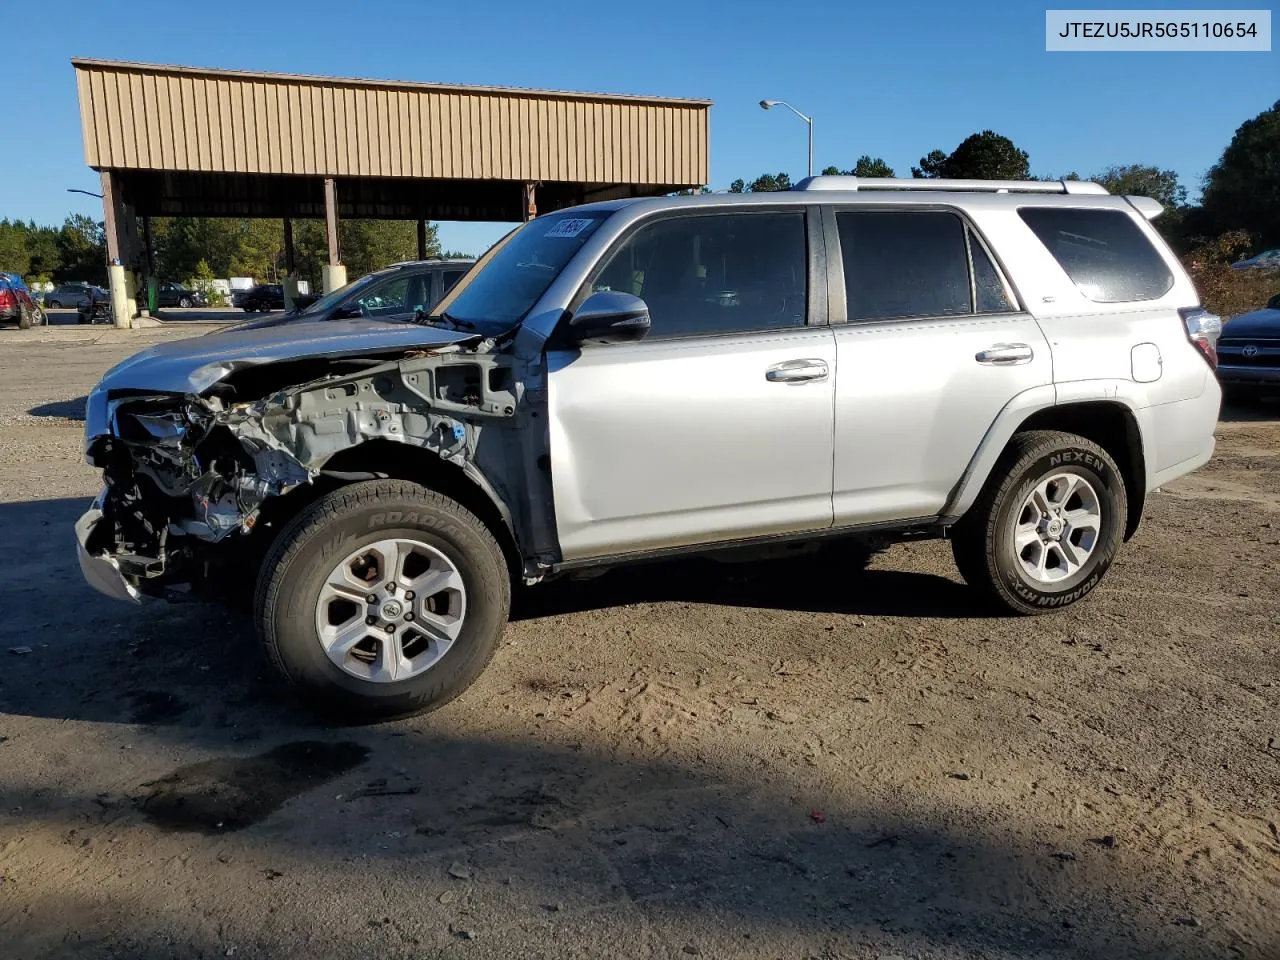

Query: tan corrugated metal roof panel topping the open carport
<box><xmin>72</xmin><ymin>59</ymin><xmax>709</xmax><ymax>188</ymax></box>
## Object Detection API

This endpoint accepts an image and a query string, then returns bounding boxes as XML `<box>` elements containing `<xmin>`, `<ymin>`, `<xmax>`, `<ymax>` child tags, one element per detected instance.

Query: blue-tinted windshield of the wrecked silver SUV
<box><xmin>431</xmin><ymin>211</ymin><xmax>609</xmax><ymax>333</ymax></box>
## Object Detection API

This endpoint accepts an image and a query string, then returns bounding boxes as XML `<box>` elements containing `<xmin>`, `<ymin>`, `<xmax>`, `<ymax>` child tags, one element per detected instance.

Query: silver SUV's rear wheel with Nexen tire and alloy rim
<box><xmin>951</xmin><ymin>430</ymin><xmax>1129</xmax><ymax>614</ymax></box>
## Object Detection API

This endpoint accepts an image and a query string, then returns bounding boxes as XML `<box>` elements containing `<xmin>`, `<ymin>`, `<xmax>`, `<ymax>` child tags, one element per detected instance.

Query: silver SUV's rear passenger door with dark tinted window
<box><xmin>824</xmin><ymin>206</ymin><xmax>1053</xmax><ymax>526</ymax></box>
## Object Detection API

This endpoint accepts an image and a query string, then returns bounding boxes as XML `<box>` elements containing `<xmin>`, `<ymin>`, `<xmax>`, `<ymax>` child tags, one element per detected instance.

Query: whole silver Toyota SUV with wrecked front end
<box><xmin>77</xmin><ymin>177</ymin><xmax>1221</xmax><ymax>718</ymax></box>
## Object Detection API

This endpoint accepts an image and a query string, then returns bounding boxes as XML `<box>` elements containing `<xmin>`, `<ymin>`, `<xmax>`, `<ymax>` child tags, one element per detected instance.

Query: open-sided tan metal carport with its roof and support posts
<box><xmin>72</xmin><ymin>59</ymin><xmax>710</xmax><ymax>325</ymax></box>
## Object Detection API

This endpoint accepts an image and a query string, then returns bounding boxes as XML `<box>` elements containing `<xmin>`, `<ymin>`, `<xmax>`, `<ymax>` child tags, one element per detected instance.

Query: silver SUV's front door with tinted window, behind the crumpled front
<box><xmin>548</xmin><ymin>207</ymin><xmax>836</xmax><ymax>559</ymax></box>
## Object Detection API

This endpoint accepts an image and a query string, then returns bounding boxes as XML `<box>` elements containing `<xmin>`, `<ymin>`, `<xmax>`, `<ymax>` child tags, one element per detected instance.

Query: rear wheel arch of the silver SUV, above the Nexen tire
<box><xmin>945</xmin><ymin>394</ymin><xmax>1151</xmax><ymax>540</ymax></box>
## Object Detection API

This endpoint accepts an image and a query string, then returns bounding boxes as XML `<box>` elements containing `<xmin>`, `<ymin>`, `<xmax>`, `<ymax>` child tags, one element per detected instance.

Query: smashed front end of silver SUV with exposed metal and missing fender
<box><xmin>77</xmin><ymin>338</ymin><xmax>524</xmax><ymax>599</ymax></box>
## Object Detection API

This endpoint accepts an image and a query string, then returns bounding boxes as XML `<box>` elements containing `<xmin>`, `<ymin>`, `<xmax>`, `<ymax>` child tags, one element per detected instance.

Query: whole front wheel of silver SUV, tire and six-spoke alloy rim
<box><xmin>255</xmin><ymin>480</ymin><xmax>511</xmax><ymax>721</ymax></box>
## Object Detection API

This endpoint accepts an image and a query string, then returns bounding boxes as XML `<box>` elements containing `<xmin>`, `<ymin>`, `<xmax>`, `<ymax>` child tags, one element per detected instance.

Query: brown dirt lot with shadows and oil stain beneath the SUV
<box><xmin>0</xmin><ymin>330</ymin><xmax>1280</xmax><ymax>960</ymax></box>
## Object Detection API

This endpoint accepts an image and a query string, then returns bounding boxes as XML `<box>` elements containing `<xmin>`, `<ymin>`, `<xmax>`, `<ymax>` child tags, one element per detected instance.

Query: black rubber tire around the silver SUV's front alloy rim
<box><xmin>255</xmin><ymin>480</ymin><xmax>511</xmax><ymax>722</ymax></box>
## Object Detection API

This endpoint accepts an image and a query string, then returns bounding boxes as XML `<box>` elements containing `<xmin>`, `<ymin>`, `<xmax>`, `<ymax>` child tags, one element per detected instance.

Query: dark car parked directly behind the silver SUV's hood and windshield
<box><xmin>241</xmin><ymin>260</ymin><xmax>475</xmax><ymax>326</ymax></box>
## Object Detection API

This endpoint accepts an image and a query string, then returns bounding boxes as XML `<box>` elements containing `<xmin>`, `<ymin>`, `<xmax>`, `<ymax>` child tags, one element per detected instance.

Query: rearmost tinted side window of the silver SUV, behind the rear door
<box><xmin>1018</xmin><ymin>206</ymin><xmax>1174</xmax><ymax>303</ymax></box>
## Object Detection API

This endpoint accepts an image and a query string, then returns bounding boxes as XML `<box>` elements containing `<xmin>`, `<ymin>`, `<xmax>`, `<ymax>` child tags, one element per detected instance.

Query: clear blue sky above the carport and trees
<box><xmin>0</xmin><ymin>0</ymin><xmax>1280</xmax><ymax>252</ymax></box>
